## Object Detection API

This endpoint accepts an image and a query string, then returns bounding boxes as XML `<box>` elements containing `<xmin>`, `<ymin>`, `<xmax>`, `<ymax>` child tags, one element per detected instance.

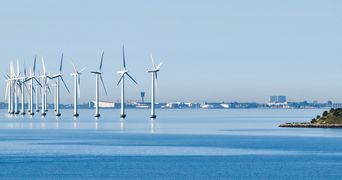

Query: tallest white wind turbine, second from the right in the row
<box><xmin>117</xmin><ymin>46</ymin><xmax>138</xmax><ymax>118</ymax></box>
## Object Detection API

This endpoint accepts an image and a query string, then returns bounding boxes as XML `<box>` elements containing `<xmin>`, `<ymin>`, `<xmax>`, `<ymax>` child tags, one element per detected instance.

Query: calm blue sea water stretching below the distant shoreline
<box><xmin>0</xmin><ymin>109</ymin><xmax>342</xmax><ymax>179</ymax></box>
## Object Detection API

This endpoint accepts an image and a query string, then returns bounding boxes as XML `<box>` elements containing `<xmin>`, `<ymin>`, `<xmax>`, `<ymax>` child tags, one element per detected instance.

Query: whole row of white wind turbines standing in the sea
<box><xmin>4</xmin><ymin>46</ymin><xmax>162</xmax><ymax>119</ymax></box>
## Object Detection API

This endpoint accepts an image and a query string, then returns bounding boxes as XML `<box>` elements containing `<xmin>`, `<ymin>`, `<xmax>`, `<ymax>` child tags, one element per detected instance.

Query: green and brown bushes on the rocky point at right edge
<box><xmin>311</xmin><ymin>108</ymin><xmax>342</xmax><ymax>124</ymax></box>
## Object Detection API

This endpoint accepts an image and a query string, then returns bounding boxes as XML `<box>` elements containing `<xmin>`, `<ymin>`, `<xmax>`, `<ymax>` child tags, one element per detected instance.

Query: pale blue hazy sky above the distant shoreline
<box><xmin>0</xmin><ymin>0</ymin><xmax>342</xmax><ymax>103</ymax></box>
